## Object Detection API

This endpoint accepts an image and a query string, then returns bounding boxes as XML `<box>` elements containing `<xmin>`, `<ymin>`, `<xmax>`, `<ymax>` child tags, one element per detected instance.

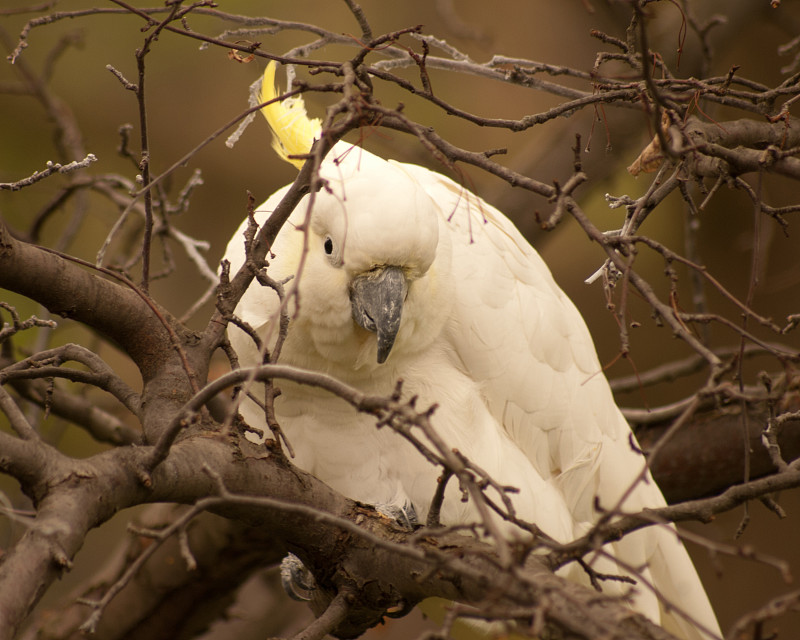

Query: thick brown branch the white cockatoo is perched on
<box><xmin>0</xmin><ymin>428</ymin><xmax>684</xmax><ymax>639</ymax></box>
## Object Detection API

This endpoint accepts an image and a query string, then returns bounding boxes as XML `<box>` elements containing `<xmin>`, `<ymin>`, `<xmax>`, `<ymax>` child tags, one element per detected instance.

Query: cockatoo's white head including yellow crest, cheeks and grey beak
<box><xmin>250</xmin><ymin>63</ymin><xmax>449</xmax><ymax>369</ymax></box>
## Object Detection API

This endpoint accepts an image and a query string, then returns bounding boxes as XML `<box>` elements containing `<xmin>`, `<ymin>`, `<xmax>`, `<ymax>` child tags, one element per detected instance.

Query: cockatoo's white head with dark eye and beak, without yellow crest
<box><xmin>300</xmin><ymin>145</ymin><xmax>439</xmax><ymax>363</ymax></box>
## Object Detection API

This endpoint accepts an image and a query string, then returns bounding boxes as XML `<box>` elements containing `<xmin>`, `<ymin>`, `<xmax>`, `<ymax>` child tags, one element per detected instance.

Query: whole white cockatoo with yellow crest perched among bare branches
<box><xmin>225</xmin><ymin>65</ymin><xmax>719</xmax><ymax>639</ymax></box>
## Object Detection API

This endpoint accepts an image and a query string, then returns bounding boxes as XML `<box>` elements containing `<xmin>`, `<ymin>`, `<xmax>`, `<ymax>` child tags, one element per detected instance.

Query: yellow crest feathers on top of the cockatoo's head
<box><xmin>261</xmin><ymin>61</ymin><xmax>322</xmax><ymax>169</ymax></box>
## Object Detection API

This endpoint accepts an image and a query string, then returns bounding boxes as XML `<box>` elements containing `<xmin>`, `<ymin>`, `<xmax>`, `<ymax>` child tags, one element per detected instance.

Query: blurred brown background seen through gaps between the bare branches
<box><xmin>0</xmin><ymin>0</ymin><xmax>800</xmax><ymax>638</ymax></box>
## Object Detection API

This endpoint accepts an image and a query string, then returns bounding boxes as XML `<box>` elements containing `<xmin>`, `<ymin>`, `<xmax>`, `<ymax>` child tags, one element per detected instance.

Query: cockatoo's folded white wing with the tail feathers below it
<box><xmin>395</xmin><ymin>158</ymin><xmax>719</xmax><ymax>639</ymax></box>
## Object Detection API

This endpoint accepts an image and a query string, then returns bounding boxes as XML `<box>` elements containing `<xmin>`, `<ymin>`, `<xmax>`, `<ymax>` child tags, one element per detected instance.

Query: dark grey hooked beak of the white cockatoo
<box><xmin>350</xmin><ymin>266</ymin><xmax>408</xmax><ymax>363</ymax></box>
